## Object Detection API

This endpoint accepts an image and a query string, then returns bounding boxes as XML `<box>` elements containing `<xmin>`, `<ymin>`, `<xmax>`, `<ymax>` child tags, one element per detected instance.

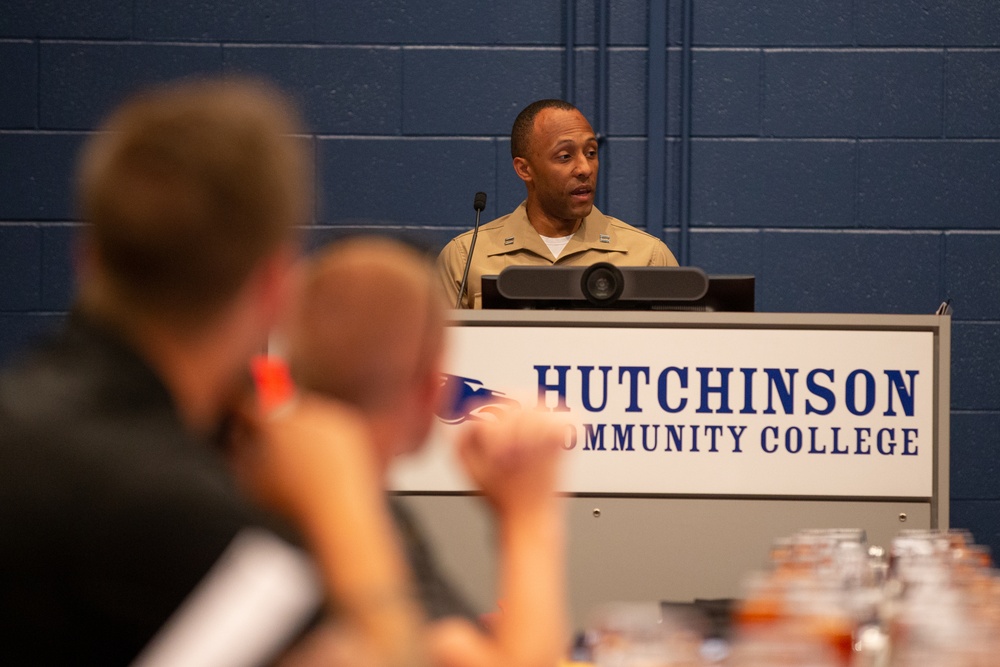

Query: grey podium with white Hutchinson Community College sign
<box><xmin>386</xmin><ymin>311</ymin><xmax>950</xmax><ymax>620</ymax></box>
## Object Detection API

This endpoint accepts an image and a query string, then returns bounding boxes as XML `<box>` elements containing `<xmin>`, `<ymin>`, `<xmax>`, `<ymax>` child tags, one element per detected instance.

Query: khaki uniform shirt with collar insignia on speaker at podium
<box><xmin>437</xmin><ymin>202</ymin><xmax>677</xmax><ymax>308</ymax></box>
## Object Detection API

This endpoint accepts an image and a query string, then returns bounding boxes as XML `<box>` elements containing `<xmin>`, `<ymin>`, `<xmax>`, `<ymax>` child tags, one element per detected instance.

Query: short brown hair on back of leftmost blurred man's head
<box><xmin>77</xmin><ymin>80</ymin><xmax>311</xmax><ymax>334</ymax></box>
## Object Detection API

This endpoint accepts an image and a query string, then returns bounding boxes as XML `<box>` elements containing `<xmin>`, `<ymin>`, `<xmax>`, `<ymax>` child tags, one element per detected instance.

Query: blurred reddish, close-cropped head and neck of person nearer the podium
<box><xmin>287</xmin><ymin>238</ymin><xmax>445</xmax><ymax>469</ymax></box>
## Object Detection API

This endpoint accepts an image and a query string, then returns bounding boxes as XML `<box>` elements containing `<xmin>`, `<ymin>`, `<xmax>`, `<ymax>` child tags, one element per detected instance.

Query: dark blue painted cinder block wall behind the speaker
<box><xmin>0</xmin><ymin>0</ymin><xmax>1000</xmax><ymax>554</ymax></box>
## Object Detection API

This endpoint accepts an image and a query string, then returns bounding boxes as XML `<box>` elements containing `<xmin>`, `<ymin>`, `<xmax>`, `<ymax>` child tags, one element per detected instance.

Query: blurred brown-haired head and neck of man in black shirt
<box><xmin>77</xmin><ymin>80</ymin><xmax>312</xmax><ymax>429</ymax></box>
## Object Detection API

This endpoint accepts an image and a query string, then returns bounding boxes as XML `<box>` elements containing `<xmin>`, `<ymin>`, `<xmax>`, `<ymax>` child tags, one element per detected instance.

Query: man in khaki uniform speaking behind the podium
<box><xmin>438</xmin><ymin>100</ymin><xmax>677</xmax><ymax>308</ymax></box>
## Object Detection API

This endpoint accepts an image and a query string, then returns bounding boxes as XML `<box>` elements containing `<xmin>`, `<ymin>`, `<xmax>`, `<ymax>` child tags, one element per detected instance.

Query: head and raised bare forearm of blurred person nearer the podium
<box><xmin>288</xmin><ymin>239</ymin><xmax>567</xmax><ymax>667</ymax></box>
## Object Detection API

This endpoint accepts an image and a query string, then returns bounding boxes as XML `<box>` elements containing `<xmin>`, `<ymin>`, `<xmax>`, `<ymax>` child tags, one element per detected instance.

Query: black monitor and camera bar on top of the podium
<box><xmin>482</xmin><ymin>262</ymin><xmax>754</xmax><ymax>312</ymax></box>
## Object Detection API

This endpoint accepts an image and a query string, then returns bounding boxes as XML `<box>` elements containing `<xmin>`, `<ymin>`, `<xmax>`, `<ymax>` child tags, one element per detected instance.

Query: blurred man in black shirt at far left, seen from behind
<box><xmin>0</xmin><ymin>81</ymin><xmax>420</xmax><ymax>667</ymax></box>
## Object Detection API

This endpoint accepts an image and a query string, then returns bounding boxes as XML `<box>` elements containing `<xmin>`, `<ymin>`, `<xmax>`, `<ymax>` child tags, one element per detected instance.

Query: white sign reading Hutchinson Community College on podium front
<box><xmin>398</xmin><ymin>327</ymin><xmax>936</xmax><ymax>498</ymax></box>
